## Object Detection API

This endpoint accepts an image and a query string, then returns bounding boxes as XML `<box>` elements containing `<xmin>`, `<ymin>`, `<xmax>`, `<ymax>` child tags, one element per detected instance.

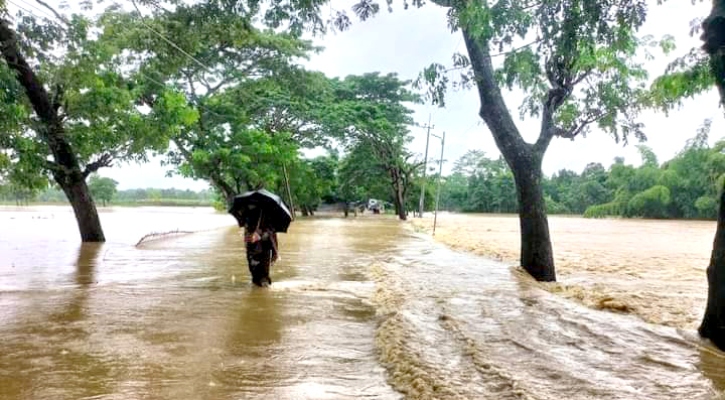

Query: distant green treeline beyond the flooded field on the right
<box><xmin>441</xmin><ymin>127</ymin><xmax>725</xmax><ymax>219</ymax></box>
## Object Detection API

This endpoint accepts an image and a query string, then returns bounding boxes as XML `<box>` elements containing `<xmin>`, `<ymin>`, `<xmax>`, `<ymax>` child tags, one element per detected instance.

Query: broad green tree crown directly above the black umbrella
<box><xmin>102</xmin><ymin>1</ymin><xmax>336</xmax><ymax>201</ymax></box>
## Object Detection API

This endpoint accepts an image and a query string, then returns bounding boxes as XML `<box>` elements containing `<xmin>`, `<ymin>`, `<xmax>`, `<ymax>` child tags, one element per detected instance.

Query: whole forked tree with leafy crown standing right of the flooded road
<box><xmin>330</xmin><ymin>0</ymin><xmax>646</xmax><ymax>281</ymax></box>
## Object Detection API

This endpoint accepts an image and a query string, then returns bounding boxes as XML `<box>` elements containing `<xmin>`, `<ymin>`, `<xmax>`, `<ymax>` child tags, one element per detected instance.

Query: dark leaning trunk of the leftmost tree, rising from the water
<box><xmin>0</xmin><ymin>20</ymin><xmax>104</xmax><ymax>242</ymax></box>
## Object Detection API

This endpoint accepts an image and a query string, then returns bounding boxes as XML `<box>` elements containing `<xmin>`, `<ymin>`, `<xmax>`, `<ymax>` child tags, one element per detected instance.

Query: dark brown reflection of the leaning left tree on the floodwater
<box><xmin>0</xmin><ymin>244</ymin><xmax>111</xmax><ymax>399</ymax></box>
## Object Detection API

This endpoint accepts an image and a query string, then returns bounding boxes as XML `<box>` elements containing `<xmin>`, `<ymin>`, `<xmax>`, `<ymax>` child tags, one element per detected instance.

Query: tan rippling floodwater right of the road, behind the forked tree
<box><xmin>412</xmin><ymin>213</ymin><xmax>715</xmax><ymax>329</ymax></box>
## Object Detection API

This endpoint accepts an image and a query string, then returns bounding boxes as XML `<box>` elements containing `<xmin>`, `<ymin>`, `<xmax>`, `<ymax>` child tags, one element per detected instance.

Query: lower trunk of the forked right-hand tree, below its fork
<box><xmin>512</xmin><ymin>160</ymin><xmax>556</xmax><ymax>282</ymax></box>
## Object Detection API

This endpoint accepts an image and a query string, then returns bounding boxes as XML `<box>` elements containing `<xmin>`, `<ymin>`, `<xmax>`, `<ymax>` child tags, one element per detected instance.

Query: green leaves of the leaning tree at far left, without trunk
<box><xmin>0</xmin><ymin>8</ymin><xmax>195</xmax><ymax>199</ymax></box>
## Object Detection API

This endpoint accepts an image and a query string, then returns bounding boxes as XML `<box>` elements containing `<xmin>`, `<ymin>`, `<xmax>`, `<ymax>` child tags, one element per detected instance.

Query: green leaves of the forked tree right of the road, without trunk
<box><xmin>378</xmin><ymin>0</ymin><xmax>656</xmax><ymax>141</ymax></box>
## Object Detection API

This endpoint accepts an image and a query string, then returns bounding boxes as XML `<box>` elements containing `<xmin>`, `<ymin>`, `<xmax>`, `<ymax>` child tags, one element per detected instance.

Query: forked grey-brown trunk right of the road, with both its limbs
<box><xmin>461</xmin><ymin>27</ymin><xmax>563</xmax><ymax>281</ymax></box>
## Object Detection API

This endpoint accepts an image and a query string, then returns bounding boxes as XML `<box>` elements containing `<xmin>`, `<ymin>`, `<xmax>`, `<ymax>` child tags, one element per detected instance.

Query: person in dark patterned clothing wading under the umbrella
<box><xmin>243</xmin><ymin>205</ymin><xmax>279</xmax><ymax>286</ymax></box>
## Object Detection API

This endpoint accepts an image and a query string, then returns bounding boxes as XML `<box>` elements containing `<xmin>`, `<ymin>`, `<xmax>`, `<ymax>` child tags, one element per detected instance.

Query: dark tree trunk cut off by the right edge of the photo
<box><xmin>698</xmin><ymin>0</ymin><xmax>725</xmax><ymax>350</ymax></box>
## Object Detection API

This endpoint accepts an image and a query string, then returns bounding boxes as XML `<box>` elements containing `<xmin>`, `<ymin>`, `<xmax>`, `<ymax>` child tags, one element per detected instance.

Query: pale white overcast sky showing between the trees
<box><xmin>11</xmin><ymin>0</ymin><xmax>725</xmax><ymax>189</ymax></box>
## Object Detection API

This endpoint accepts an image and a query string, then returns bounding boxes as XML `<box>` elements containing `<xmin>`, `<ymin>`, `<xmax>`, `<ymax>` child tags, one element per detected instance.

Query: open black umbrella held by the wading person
<box><xmin>229</xmin><ymin>189</ymin><xmax>292</xmax><ymax>232</ymax></box>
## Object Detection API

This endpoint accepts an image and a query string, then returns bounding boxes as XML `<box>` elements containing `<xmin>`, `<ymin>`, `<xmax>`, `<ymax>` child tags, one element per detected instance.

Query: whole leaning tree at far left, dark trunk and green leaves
<box><xmin>0</xmin><ymin>7</ymin><xmax>191</xmax><ymax>242</ymax></box>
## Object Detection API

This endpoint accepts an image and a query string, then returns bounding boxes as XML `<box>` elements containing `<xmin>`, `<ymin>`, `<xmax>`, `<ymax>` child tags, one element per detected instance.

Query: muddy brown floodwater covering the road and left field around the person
<box><xmin>0</xmin><ymin>208</ymin><xmax>725</xmax><ymax>400</ymax></box>
